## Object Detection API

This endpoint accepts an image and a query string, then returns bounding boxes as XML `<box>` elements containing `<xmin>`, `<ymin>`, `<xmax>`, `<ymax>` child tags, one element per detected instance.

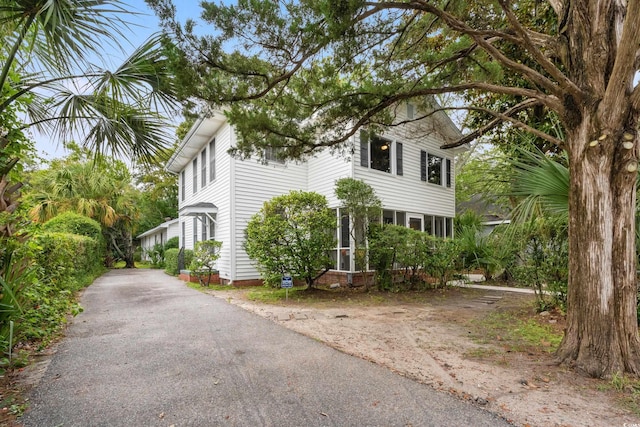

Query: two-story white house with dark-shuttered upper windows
<box><xmin>166</xmin><ymin>104</ymin><xmax>464</xmax><ymax>284</ymax></box>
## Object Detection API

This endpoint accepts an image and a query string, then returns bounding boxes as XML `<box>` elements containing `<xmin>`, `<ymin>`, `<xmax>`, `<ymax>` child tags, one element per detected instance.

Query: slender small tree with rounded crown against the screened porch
<box><xmin>334</xmin><ymin>178</ymin><xmax>382</xmax><ymax>288</ymax></box>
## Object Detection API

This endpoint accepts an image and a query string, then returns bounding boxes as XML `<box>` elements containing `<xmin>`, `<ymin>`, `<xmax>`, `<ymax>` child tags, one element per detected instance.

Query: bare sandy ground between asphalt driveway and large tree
<box><xmin>208</xmin><ymin>289</ymin><xmax>640</xmax><ymax>427</ymax></box>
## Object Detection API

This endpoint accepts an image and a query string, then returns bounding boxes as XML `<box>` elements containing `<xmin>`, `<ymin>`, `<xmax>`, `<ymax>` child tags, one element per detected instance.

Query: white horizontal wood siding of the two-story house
<box><xmin>170</xmin><ymin>106</ymin><xmax>455</xmax><ymax>281</ymax></box>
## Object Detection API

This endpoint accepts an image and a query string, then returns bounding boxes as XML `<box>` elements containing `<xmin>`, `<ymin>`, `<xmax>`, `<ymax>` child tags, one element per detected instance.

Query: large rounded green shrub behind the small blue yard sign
<box><xmin>244</xmin><ymin>191</ymin><xmax>337</xmax><ymax>288</ymax></box>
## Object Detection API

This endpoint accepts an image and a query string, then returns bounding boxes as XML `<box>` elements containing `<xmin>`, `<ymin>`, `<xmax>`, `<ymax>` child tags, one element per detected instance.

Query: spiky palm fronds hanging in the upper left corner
<box><xmin>0</xmin><ymin>0</ymin><xmax>178</xmax><ymax>164</ymax></box>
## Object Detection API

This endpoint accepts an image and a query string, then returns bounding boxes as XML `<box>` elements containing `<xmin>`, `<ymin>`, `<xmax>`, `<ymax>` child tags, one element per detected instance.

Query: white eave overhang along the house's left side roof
<box><xmin>165</xmin><ymin>110</ymin><xmax>227</xmax><ymax>174</ymax></box>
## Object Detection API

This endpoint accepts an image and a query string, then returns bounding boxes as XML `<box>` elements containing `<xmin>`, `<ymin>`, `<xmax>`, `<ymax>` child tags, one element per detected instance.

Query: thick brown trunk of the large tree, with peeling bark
<box><xmin>557</xmin><ymin>111</ymin><xmax>640</xmax><ymax>377</ymax></box>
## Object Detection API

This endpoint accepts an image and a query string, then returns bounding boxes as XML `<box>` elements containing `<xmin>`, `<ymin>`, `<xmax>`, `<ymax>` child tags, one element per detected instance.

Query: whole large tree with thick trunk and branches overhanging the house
<box><xmin>147</xmin><ymin>0</ymin><xmax>640</xmax><ymax>376</ymax></box>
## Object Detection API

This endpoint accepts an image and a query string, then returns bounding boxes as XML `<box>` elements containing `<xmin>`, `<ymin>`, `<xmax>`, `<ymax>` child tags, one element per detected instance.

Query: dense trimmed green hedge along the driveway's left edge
<box><xmin>0</xmin><ymin>214</ymin><xmax>105</xmax><ymax>347</ymax></box>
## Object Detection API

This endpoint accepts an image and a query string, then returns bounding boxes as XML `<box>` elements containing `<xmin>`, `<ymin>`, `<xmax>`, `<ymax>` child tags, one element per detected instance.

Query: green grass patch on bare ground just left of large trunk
<box><xmin>469</xmin><ymin>312</ymin><xmax>562</xmax><ymax>353</ymax></box>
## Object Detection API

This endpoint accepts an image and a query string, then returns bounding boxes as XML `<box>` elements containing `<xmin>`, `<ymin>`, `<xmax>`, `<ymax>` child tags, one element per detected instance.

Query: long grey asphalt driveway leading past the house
<box><xmin>22</xmin><ymin>270</ymin><xmax>508</xmax><ymax>427</ymax></box>
